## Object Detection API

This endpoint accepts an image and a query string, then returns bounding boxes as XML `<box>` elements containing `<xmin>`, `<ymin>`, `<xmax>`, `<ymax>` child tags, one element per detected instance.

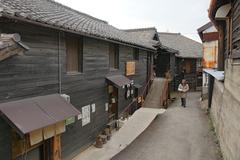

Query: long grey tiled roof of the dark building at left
<box><xmin>0</xmin><ymin>0</ymin><xmax>155</xmax><ymax>50</ymax></box>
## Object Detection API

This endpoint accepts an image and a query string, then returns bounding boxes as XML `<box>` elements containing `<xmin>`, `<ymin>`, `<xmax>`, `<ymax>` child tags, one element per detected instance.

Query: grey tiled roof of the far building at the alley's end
<box><xmin>158</xmin><ymin>32</ymin><xmax>202</xmax><ymax>58</ymax></box>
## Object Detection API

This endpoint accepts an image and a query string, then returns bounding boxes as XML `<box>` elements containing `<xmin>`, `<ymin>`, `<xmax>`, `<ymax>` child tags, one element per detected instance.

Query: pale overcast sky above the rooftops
<box><xmin>56</xmin><ymin>0</ymin><xmax>210</xmax><ymax>41</ymax></box>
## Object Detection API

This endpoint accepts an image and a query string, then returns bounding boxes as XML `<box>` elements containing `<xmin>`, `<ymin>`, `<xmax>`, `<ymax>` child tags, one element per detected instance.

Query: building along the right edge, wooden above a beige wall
<box><xmin>209</xmin><ymin>0</ymin><xmax>240</xmax><ymax>160</ymax></box>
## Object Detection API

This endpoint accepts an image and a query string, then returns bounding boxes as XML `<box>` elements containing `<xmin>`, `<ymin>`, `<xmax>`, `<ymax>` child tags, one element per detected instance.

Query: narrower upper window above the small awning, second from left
<box><xmin>109</xmin><ymin>44</ymin><xmax>119</xmax><ymax>69</ymax></box>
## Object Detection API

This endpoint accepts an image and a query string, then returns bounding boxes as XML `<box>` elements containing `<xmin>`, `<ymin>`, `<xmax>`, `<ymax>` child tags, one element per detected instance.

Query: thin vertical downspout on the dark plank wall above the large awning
<box><xmin>58</xmin><ymin>31</ymin><xmax>62</xmax><ymax>94</ymax></box>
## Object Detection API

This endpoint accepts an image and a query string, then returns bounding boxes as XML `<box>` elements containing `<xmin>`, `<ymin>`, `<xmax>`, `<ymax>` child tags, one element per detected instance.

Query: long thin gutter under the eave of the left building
<box><xmin>0</xmin><ymin>13</ymin><xmax>157</xmax><ymax>53</ymax></box>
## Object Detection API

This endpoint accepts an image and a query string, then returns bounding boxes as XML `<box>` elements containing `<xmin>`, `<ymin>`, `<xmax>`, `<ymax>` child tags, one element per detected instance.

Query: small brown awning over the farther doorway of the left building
<box><xmin>106</xmin><ymin>75</ymin><xmax>132</xmax><ymax>87</ymax></box>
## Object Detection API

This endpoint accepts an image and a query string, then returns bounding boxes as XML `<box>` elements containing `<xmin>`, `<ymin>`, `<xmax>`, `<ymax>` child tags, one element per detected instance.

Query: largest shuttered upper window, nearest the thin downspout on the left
<box><xmin>66</xmin><ymin>36</ymin><xmax>83</xmax><ymax>74</ymax></box>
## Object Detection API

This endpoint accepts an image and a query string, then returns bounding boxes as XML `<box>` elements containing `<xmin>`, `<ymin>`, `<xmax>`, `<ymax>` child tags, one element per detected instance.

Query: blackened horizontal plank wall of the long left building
<box><xmin>0</xmin><ymin>19</ymin><xmax>152</xmax><ymax>160</ymax></box>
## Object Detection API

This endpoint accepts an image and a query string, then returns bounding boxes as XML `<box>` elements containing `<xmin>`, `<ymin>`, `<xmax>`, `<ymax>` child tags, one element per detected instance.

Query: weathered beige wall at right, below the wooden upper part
<box><xmin>211</xmin><ymin>60</ymin><xmax>240</xmax><ymax>160</ymax></box>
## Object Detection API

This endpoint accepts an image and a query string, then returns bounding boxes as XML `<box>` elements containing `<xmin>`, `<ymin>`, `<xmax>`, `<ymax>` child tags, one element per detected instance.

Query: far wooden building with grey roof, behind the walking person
<box><xmin>159</xmin><ymin>32</ymin><xmax>202</xmax><ymax>90</ymax></box>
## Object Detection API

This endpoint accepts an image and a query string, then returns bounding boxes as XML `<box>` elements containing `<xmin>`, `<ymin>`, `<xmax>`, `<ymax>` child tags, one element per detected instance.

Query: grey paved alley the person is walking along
<box><xmin>113</xmin><ymin>92</ymin><xmax>219</xmax><ymax>160</ymax></box>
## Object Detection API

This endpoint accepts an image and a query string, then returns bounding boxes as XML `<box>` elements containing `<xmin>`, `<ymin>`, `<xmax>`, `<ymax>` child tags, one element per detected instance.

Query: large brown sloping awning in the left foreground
<box><xmin>0</xmin><ymin>94</ymin><xmax>80</xmax><ymax>135</ymax></box>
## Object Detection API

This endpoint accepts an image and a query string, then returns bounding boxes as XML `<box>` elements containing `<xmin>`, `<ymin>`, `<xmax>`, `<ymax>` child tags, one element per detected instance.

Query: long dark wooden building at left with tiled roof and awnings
<box><xmin>0</xmin><ymin>0</ymin><xmax>156</xmax><ymax>160</ymax></box>
